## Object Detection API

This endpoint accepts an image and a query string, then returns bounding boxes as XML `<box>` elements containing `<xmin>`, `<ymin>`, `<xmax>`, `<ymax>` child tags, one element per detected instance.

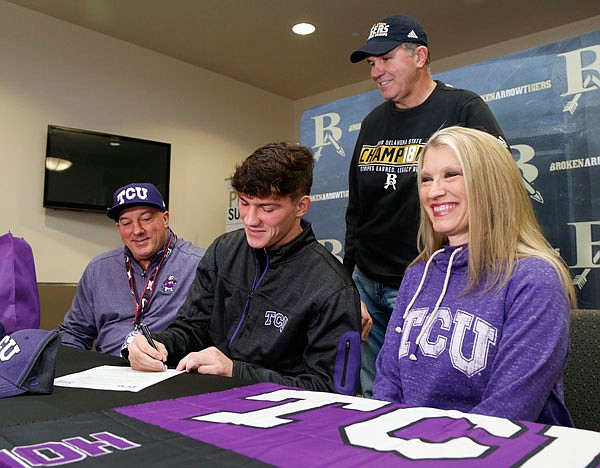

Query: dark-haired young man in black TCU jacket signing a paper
<box><xmin>128</xmin><ymin>143</ymin><xmax>360</xmax><ymax>394</ymax></box>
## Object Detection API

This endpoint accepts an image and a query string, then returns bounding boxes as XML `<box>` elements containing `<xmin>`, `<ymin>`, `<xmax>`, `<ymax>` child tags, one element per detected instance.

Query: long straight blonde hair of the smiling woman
<box><xmin>413</xmin><ymin>127</ymin><xmax>576</xmax><ymax>308</ymax></box>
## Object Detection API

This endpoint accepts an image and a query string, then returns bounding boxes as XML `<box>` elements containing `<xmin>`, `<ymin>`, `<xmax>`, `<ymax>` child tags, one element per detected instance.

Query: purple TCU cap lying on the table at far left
<box><xmin>0</xmin><ymin>328</ymin><xmax>60</xmax><ymax>398</ymax></box>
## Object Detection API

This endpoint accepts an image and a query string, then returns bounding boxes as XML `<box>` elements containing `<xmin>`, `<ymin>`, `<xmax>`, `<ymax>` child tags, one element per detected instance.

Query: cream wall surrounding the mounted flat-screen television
<box><xmin>0</xmin><ymin>0</ymin><xmax>294</xmax><ymax>283</ymax></box>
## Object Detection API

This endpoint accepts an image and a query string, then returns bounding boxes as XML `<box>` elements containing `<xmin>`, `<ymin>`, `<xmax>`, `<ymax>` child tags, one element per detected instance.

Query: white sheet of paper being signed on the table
<box><xmin>54</xmin><ymin>366</ymin><xmax>184</xmax><ymax>392</ymax></box>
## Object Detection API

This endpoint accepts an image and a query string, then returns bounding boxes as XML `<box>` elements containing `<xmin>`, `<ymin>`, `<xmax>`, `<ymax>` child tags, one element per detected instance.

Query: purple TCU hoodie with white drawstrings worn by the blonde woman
<box><xmin>373</xmin><ymin>245</ymin><xmax>573</xmax><ymax>426</ymax></box>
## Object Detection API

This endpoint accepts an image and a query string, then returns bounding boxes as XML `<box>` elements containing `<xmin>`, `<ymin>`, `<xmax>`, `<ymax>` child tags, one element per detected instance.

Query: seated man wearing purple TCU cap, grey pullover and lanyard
<box><xmin>59</xmin><ymin>183</ymin><xmax>204</xmax><ymax>356</ymax></box>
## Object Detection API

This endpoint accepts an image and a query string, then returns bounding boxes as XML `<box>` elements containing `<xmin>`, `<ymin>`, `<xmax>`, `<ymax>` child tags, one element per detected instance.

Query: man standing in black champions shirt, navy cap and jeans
<box><xmin>344</xmin><ymin>15</ymin><xmax>504</xmax><ymax>397</ymax></box>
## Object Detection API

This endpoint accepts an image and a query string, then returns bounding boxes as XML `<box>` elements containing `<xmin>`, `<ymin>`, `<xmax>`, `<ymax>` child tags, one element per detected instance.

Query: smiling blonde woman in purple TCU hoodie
<box><xmin>374</xmin><ymin>127</ymin><xmax>575</xmax><ymax>426</ymax></box>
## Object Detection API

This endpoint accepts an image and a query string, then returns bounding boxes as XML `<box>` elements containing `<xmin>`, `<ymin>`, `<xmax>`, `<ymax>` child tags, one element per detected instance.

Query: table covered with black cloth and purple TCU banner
<box><xmin>0</xmin><ymin>346</ymin><xmax>600</xmax><ymax>468</ymax></box>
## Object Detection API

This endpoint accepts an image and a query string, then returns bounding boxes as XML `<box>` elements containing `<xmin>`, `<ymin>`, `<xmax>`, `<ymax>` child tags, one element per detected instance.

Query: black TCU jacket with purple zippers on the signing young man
<box><xmin>156</xmin><ymin>221</ymin><xmax>360</xmax><ymax>394</ymax></box>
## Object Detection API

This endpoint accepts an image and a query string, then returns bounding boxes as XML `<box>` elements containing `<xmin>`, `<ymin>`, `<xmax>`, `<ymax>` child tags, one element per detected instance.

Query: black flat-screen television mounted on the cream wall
<box><xmin>44</xmin><ymin>125</ymin><xmax>171</xmax><ymax>212</ymax></box>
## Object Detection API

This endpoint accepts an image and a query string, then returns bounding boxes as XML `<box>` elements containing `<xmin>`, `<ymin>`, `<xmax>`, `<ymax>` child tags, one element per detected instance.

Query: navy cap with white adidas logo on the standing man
<box><xmin>350</xmin><ymin>15</ymin><xmax>427</xmax><ymax>63</ymax></box>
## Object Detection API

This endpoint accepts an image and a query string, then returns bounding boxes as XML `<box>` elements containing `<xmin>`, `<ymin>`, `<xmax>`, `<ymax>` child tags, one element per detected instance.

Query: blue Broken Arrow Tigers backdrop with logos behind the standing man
<box><xmin>300</xmin><ymin>31</ymin><xmax>600</xmax><ymax>308</ymax></box>
